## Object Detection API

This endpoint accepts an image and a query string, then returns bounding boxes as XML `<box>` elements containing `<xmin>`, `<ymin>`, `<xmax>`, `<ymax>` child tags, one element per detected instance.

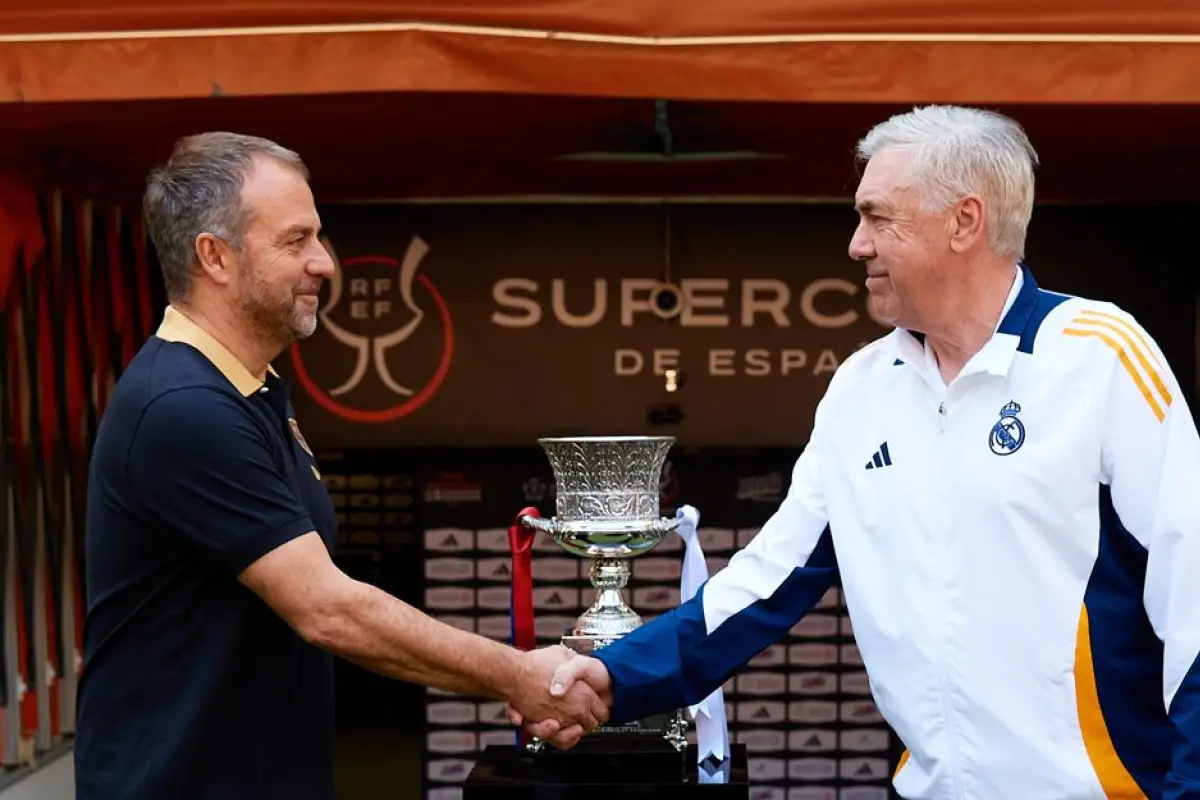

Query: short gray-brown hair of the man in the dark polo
<box><xmin>142</xmin><ymin>132</ymin><xmax>308</xmax><ymax>302</ymax></box>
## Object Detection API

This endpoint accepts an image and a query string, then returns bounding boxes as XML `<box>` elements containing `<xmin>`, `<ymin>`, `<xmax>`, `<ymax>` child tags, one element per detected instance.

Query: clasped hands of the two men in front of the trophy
<box><xmin>508</xmin><ymin>644</ymin><xmax>612</xmax><ymax>750</ymax></box>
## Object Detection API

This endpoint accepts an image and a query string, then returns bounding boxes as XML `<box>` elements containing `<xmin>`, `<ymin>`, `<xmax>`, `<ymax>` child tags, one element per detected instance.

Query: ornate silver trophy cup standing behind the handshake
<box><xmin>521</xmin><ymin>437</ymin><xmax>688</xmax><ymax>751</ymax></box>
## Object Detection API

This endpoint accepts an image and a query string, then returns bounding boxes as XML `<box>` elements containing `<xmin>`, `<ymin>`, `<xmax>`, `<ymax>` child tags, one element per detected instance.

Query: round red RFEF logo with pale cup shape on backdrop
<box><xmin>292</xmin><ymin>236</ymin><xmax>454</xmax><ymax>423</ymax></box>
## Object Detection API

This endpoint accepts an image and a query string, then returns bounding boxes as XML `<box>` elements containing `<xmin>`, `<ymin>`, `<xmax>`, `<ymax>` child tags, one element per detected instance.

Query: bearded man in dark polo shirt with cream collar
<box><xmin>74</xmin><ymin>133</ymin><xmax>607</xmax><ymax>800</ymax></box>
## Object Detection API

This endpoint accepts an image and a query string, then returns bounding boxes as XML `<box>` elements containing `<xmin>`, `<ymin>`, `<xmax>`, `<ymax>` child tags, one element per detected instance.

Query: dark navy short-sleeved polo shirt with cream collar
<box><xmin>74</xmin><ymin>309</ymin><xmax>336</xmax><ymax>800</ymax></box>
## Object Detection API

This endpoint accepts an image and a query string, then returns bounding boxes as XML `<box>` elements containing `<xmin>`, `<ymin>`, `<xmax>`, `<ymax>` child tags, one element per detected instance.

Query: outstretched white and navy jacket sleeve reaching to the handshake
<box><xmin>594</xmin><ymin>393</ymin><xmax>838</xmax><ymax>724</ymax></box>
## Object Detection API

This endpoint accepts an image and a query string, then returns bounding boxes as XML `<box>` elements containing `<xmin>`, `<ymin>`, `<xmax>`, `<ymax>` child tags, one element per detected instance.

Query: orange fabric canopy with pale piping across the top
<box><xmin>0</xmin><ymin>0</ymin><xmax>1200</xmax><ymax>104</ymax></box>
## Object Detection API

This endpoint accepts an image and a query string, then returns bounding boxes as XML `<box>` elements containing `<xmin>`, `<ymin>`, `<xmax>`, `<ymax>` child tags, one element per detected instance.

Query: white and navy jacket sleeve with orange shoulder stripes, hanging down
<box><xmin>1087</xmin><ymin>309</ymin><xmax>1200</xmax><ymax>800</ymax></box>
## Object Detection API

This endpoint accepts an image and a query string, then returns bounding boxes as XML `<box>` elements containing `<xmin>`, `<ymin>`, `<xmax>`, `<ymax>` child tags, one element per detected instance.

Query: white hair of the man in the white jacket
<box><xmin>857</xmin><ymin>106</ymin><xmax>1038</xmax><ymax>260</ymax></box>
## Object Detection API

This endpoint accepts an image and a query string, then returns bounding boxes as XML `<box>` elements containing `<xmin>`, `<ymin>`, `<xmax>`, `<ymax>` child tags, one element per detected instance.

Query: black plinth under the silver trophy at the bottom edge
<box><xmin>462</xmin><ymin>735</ymin><xmax>750</xmax><ymax>800</ymax></box>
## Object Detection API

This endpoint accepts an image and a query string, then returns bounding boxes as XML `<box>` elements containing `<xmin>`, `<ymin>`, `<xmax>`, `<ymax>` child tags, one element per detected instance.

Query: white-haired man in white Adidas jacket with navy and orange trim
<box><xmin>514</xmin><ymin>107</ymin><xmax>1200</xmax><ymax>800</ymax></box>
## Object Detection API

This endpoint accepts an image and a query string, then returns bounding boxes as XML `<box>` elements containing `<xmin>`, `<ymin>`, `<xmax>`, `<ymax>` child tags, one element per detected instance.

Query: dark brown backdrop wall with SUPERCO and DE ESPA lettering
<box><xmin>277</xmin><ymin>205</ymin><xmax>1196</xmax><ymax>446</ymax></box>
